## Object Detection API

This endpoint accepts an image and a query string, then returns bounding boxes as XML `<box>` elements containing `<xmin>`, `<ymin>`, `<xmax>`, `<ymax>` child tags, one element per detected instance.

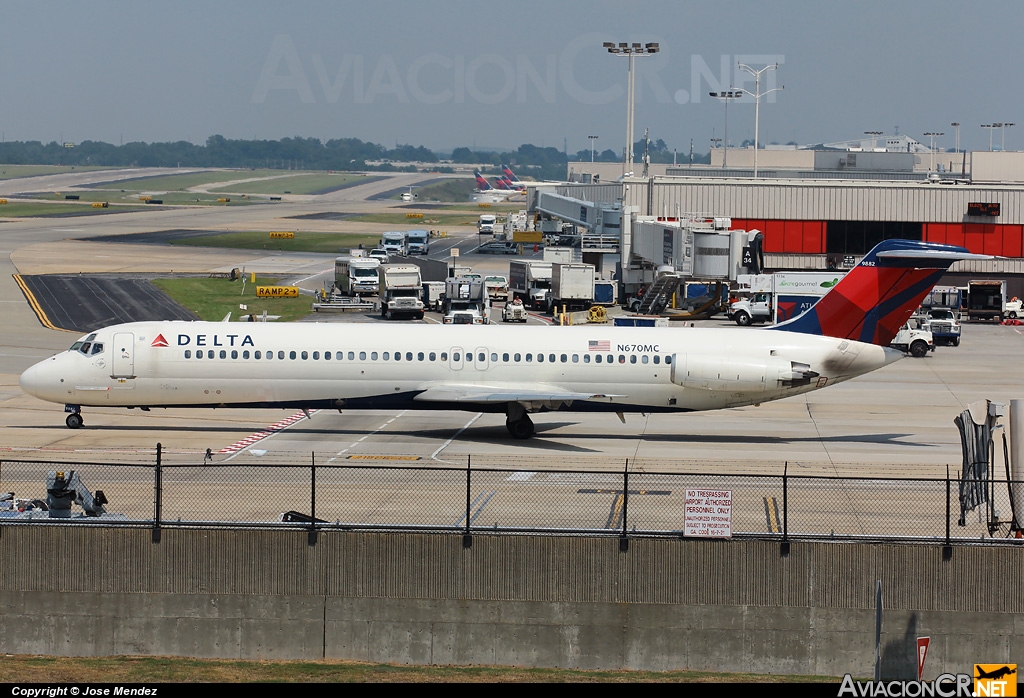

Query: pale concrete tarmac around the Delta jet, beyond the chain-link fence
<box><xmin>0</xmin><ymin>167</ymin><xmax>1024</xmax><ymax>491</ymax></box>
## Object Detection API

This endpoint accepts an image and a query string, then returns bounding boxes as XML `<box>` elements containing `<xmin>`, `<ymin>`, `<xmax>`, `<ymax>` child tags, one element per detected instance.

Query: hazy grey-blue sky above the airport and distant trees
<box><xmin>0</xmin><ymin>0</ymin><xmax>1024</xmax><ymax>154</ymax></box>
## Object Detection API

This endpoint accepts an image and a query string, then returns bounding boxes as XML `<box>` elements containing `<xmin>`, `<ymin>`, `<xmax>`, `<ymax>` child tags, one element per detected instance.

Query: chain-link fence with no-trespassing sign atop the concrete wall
<box><xmin>0</xmin><ymin>450</ymin><xmax>1024</xmax><ymax>542</ymax></box>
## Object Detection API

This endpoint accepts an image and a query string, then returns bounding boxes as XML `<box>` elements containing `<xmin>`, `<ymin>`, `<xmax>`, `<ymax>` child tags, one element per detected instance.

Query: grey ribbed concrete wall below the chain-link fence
<box><xmin>0</xmin><ymin>524</ymin><xmax>1024</xmax><ymax>678</ymax></box>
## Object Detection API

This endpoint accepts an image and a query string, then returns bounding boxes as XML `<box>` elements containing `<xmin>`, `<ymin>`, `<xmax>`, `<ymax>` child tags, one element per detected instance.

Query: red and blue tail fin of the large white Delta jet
<box><xmin>775</xmin><ymin>239</ymin><xmax>991</xmax><ymax>347</ymax></box>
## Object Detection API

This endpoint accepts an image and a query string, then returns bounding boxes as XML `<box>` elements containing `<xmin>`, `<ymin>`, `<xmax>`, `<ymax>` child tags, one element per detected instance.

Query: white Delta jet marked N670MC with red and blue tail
<box><xmin>20</xmin><ymin>241</ymin><xmax>987</xmax><ymax>439</ymax></box>
